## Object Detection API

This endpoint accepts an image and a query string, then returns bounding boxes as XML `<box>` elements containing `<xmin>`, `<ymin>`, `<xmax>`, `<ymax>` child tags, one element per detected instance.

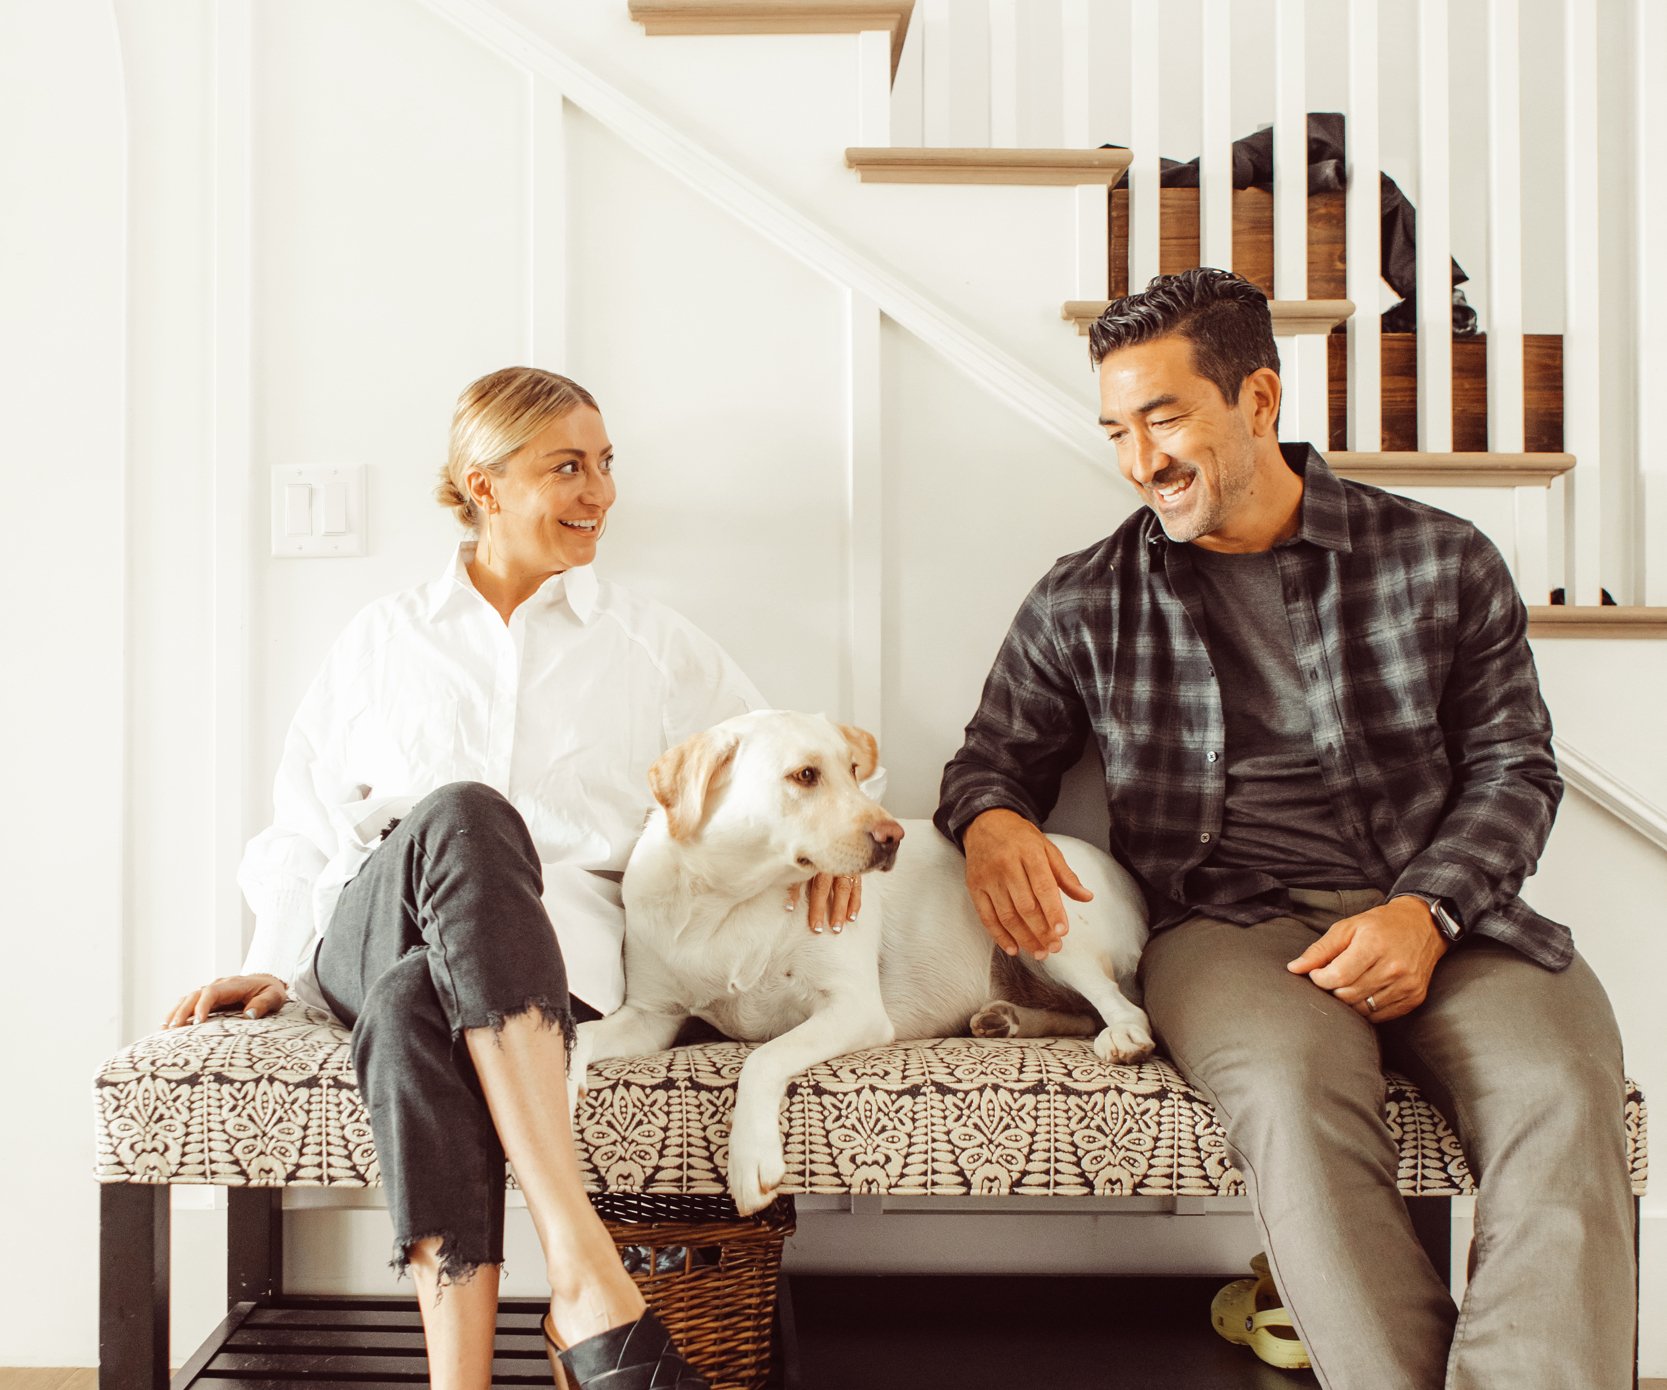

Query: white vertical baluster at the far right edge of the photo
<box><xmin>1640</xmin><ymin>3</ymin><xmax>1667</xmax><ymax>607</ymax></box>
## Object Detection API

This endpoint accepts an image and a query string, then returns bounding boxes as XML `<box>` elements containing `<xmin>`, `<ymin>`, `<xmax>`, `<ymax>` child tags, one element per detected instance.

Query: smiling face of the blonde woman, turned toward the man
<box><xmin>468</xmin><ymin>405</ymin><xmax>615</xmax><ymax>573</ymax></box>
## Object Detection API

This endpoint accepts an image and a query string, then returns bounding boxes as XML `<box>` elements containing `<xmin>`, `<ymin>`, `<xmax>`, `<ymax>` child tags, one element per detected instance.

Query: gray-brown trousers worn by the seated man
<box><xmin>1140</xmin><ymin>890</ymin><xmax>1635</xmax><ymax>1390</ymax></box>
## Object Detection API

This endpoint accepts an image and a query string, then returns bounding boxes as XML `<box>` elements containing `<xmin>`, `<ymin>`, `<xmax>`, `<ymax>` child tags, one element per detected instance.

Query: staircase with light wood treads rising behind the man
<box><xmin>610</xmin><ymin>0</ymin><xmax>1667</xmax><ymax>637</ymax></box>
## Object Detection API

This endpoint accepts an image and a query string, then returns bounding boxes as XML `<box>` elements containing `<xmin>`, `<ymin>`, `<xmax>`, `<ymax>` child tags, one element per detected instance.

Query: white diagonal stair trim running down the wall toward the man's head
<box><xmin>406</xmin><ymin>0</ymin><xmax>1110</xmax><ymax>473</ymax></box>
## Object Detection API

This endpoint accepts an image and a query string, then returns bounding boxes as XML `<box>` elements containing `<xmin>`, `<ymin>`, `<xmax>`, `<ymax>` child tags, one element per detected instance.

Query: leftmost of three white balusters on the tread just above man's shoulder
<box><xmin>1344</xmin><ymin>0</ymin><xmax>1384</xmax><ymax>453</ymax></box>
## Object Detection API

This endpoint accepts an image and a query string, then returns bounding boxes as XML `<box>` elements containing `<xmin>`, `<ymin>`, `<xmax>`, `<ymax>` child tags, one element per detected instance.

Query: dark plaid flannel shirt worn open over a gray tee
<box><xmin>935</xmin><ymin>445</ymin><xmax>1574</xmax><ymax>970</ymax></box>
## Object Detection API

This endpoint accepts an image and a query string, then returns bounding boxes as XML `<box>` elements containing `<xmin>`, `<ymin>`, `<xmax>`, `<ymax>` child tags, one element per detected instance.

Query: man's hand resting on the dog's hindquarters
<box><xmin>962</xmin><ymin>807</ymin><xmax>1094</xmax><ymax>960</ymax></box>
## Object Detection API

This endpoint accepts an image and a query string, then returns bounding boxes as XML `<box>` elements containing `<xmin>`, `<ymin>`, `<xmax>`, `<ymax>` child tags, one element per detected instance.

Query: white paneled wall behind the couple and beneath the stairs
<box><xmin>0</xmin><ymin>0</ymin><xmax>1667</xmax><ymax>1370</ymax></box>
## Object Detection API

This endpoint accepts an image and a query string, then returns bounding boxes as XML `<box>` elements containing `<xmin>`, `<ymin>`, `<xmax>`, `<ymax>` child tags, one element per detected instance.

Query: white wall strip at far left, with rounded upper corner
<box><xmin>0</xmin><ymin>0</ymin><xmax>128</xmax><ymax>1365</ymax></box>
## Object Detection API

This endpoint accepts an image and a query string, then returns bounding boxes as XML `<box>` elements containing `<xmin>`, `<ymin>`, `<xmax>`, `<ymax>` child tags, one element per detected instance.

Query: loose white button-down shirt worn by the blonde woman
<box><xmin>238</xmin><ymin>542</ymin><xmax>763</xmax><ymax>1013</ymax></box>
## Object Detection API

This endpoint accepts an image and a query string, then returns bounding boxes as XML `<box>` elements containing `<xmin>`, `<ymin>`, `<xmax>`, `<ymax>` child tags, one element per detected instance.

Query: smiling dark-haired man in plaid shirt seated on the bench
<box><xmin>937</xmin><ymin>268</ymin><xmax>1634</xmax><ymax>1390</ymax></box>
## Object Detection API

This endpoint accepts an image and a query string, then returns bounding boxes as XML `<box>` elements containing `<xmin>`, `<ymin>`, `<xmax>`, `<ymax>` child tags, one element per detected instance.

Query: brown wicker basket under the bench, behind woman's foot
<box><xmin>590</xmin><ymin>1192</ymin><xmax>793</xmax><ymax>1390</ymax></box>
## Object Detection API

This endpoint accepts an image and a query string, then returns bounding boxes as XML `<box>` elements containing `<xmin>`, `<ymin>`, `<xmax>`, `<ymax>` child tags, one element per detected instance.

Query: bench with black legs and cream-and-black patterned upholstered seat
<box><xmin>95</xmin><ymin>1003</ymin><xmax>1647</xmax><ymax>1390</ymax></box>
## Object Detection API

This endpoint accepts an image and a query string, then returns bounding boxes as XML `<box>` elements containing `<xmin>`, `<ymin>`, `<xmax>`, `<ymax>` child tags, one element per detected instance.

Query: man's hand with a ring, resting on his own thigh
<box><xmin>1285</xmin><ymin>897</ymin><xmax>1447</xmax><ymax>1023</ymax></box>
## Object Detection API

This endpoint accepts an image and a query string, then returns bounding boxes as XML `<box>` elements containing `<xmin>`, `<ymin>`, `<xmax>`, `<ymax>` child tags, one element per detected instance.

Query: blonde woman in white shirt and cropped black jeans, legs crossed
<box><xmin>167</xmin><ymin>367</ymin><xmax>859</xmax><ymax>1390</ymax></box>
